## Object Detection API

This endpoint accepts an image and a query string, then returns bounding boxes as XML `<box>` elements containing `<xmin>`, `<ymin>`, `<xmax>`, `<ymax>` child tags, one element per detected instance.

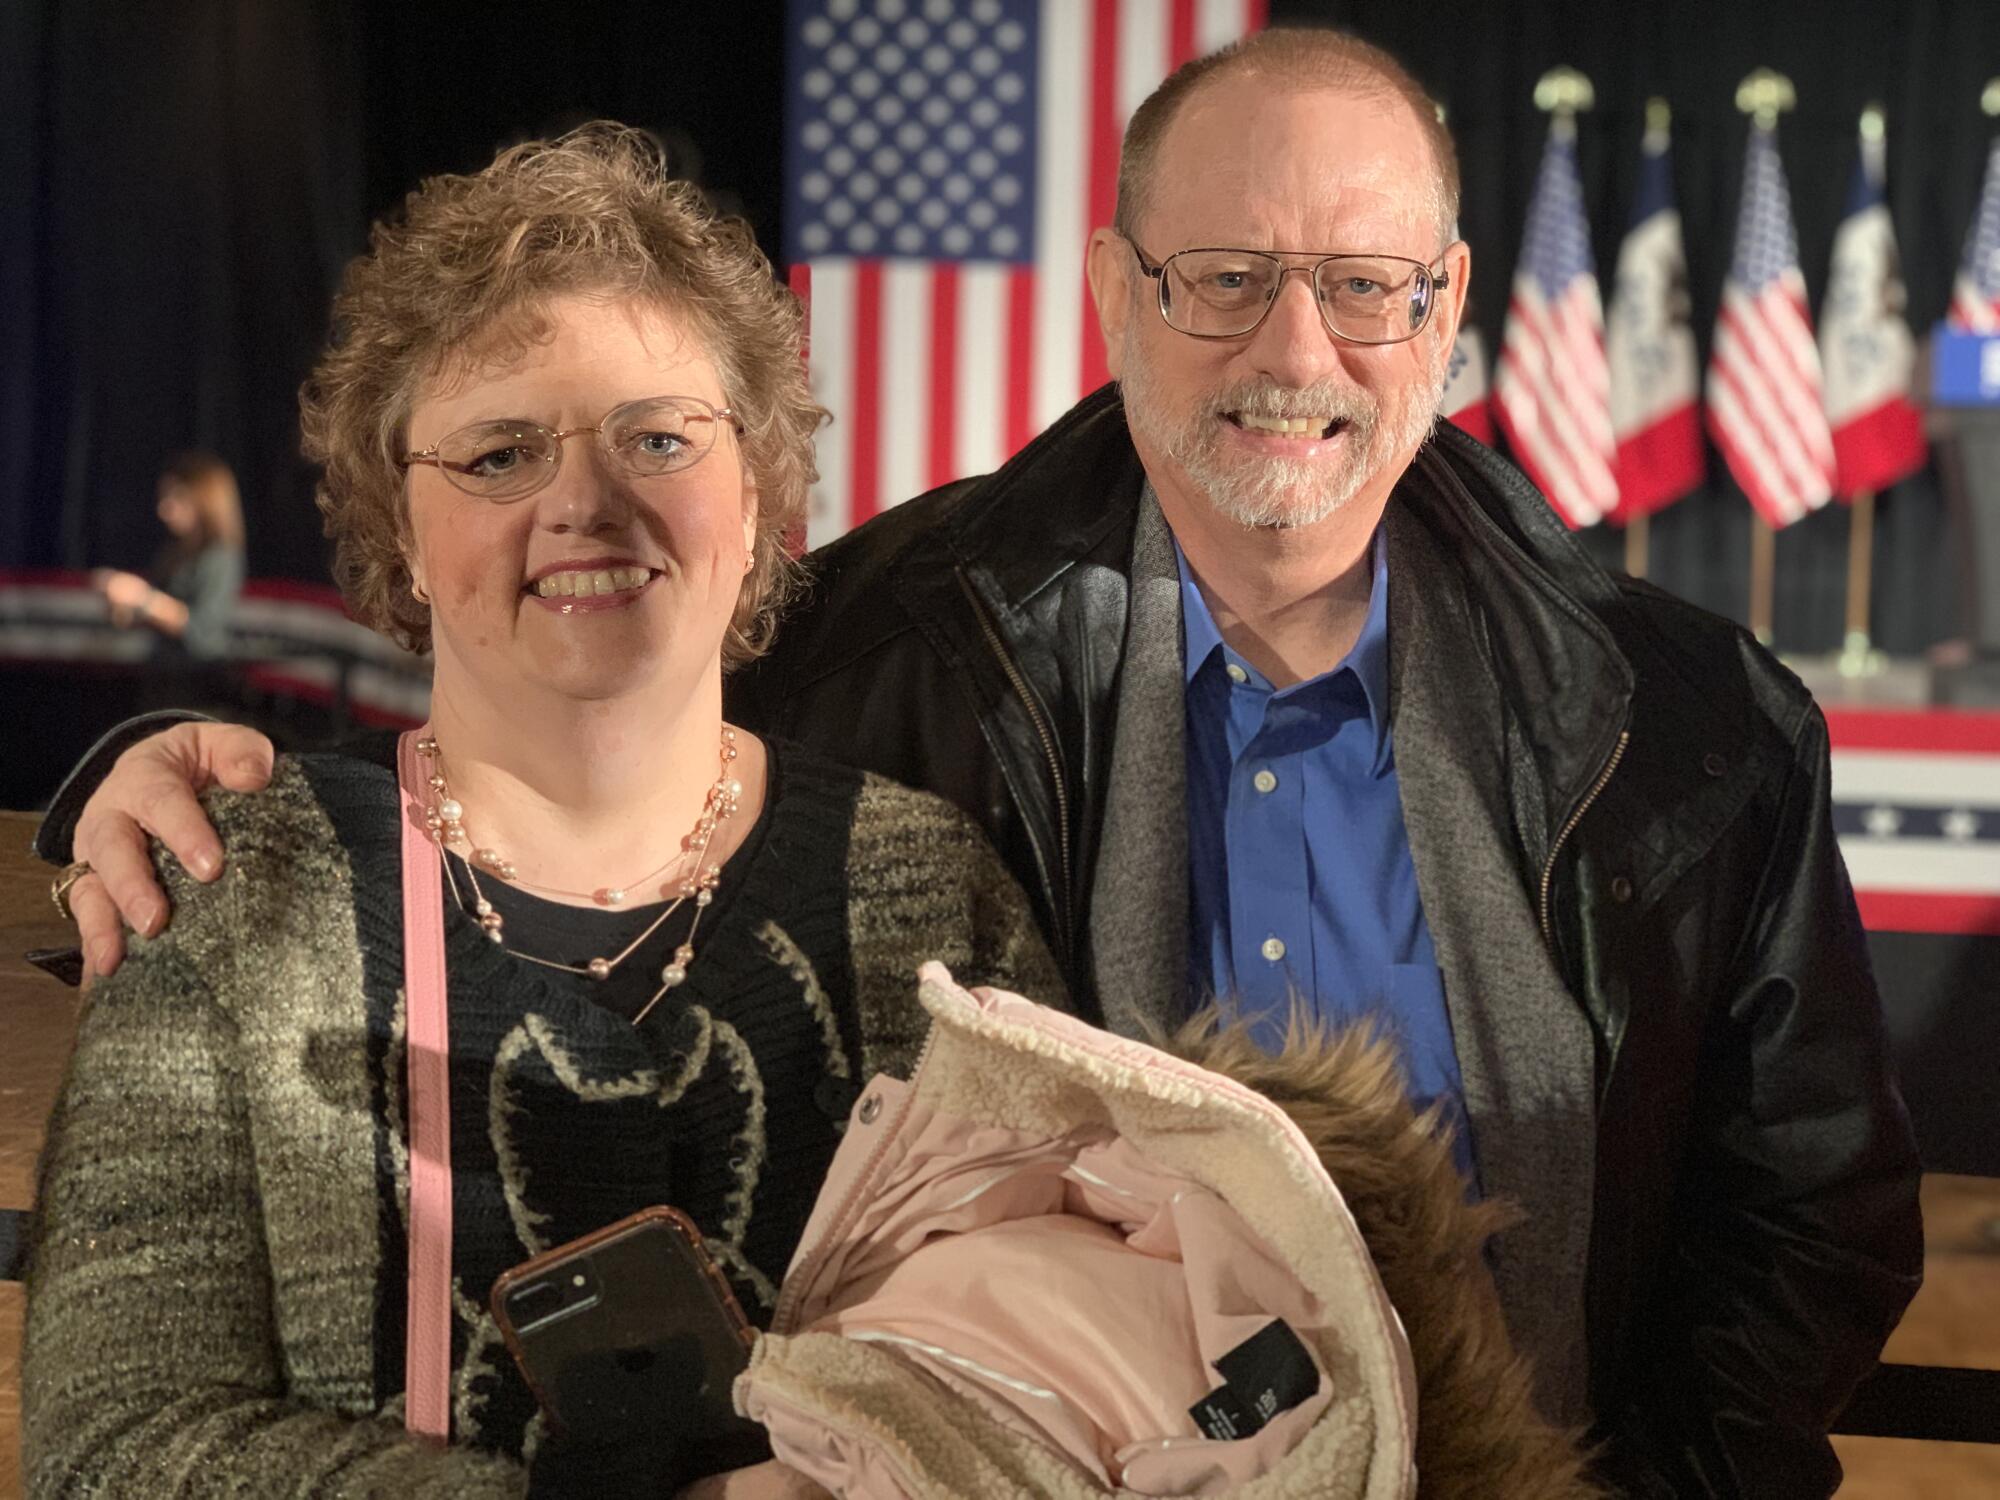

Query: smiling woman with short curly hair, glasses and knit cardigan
<box><xmin>24</xmin><ymin>126</ymin><xmax>1060</xmax><ymax>1496</ymax></box>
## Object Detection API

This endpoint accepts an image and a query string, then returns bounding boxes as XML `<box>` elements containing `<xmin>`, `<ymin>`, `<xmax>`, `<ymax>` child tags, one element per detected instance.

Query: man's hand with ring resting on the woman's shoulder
<box><xmin>70</xmin><ymin>722</ymin><xmax>274</xmax><ymax>982</ymax></box>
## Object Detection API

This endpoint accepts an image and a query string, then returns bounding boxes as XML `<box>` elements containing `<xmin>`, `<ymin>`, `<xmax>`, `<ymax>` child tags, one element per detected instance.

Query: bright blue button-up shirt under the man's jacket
<box><xmin>1174</xmin><ymin>544</ymin><xmax>1472</xmax><ymax>1176</ymax></box>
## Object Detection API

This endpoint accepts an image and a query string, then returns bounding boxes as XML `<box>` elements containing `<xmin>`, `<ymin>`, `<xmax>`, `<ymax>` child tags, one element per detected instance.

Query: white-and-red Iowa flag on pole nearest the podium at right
<box><xmin>1820</xmin><ymin>122</ymin><xmax>1928</xmax><ymax>500</ymax></box>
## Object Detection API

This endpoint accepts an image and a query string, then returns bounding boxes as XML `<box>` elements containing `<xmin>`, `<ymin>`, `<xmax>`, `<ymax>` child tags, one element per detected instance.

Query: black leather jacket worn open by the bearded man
<box><xmin>730</xmin><ymin>388</ymin><xmax>1922</xmax><ymax>1500</ymax></box>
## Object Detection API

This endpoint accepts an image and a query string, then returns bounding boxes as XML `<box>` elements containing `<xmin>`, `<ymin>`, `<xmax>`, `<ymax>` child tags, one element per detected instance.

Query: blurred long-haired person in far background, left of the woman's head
<box><xmin>92</xmin><ymin>452</ymin><xmax>244</xmax><ymax>660</ymax></box>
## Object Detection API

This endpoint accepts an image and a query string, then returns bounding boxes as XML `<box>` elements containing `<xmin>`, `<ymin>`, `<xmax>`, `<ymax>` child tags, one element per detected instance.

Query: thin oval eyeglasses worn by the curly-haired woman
<box><xmin>396</xmin><ymin>396</ymin><xmax>744</xmax><ymax>504</ymax></box>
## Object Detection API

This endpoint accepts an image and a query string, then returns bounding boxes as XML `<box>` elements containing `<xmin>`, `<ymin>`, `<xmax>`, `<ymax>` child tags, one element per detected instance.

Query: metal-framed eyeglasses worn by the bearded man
<box><xmin>1126</xmin><ymin>240</ymin><xmax>1450</xmax><ymax>344</ymax></box>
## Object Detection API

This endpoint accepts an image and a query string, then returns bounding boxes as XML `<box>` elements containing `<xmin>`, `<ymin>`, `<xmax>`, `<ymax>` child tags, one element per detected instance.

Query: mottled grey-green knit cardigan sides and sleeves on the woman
<box><xmin>22</xmin><ymin>758</ymin><xmax>1060</xmax><ymax>1500</ymax></box>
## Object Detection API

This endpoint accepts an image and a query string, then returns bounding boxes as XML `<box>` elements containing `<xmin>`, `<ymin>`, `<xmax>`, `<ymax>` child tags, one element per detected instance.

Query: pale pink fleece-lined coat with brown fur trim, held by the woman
<box><xmin>736</xmin><ymin>964</ymin><xmax>1596</xmax><ymax>1500</ymax></box>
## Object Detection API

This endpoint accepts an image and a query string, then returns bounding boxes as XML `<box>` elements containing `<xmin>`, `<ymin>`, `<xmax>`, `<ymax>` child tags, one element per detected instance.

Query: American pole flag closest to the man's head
<box><xmin>1494</xmin><ymin>114</ymin><xmax>1618</xmax><ymax>526</ymax></box>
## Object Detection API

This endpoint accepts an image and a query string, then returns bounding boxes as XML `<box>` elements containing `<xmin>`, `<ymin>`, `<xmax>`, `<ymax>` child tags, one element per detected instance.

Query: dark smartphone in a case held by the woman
<box><xmin>490</xmin><ymin>1206</ymin><xmax>770</xmax><ymax>1468</ymax></box>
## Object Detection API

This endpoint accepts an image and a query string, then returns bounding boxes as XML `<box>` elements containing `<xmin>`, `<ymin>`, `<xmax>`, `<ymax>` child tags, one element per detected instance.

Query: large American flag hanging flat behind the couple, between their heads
<box><xmin>784</xmin><ymin>0</ymin><xmax>1266</xmax><ymax>546</ymax></box>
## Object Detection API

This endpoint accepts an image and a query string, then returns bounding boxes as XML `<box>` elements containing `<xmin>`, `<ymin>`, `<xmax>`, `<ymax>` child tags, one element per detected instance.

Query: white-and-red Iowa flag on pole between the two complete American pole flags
<box><xmin>1604</xmin><ymin>116</ymin><xmax>1702</xmax><ymax>522</ymax></box>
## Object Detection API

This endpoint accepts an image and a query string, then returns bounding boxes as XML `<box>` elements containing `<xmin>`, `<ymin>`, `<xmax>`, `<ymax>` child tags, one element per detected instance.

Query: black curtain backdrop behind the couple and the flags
<box><xmin>0</xmin><ymin>0</ymin><xmax>2000</xmax><ymax>650</ymax></box>
